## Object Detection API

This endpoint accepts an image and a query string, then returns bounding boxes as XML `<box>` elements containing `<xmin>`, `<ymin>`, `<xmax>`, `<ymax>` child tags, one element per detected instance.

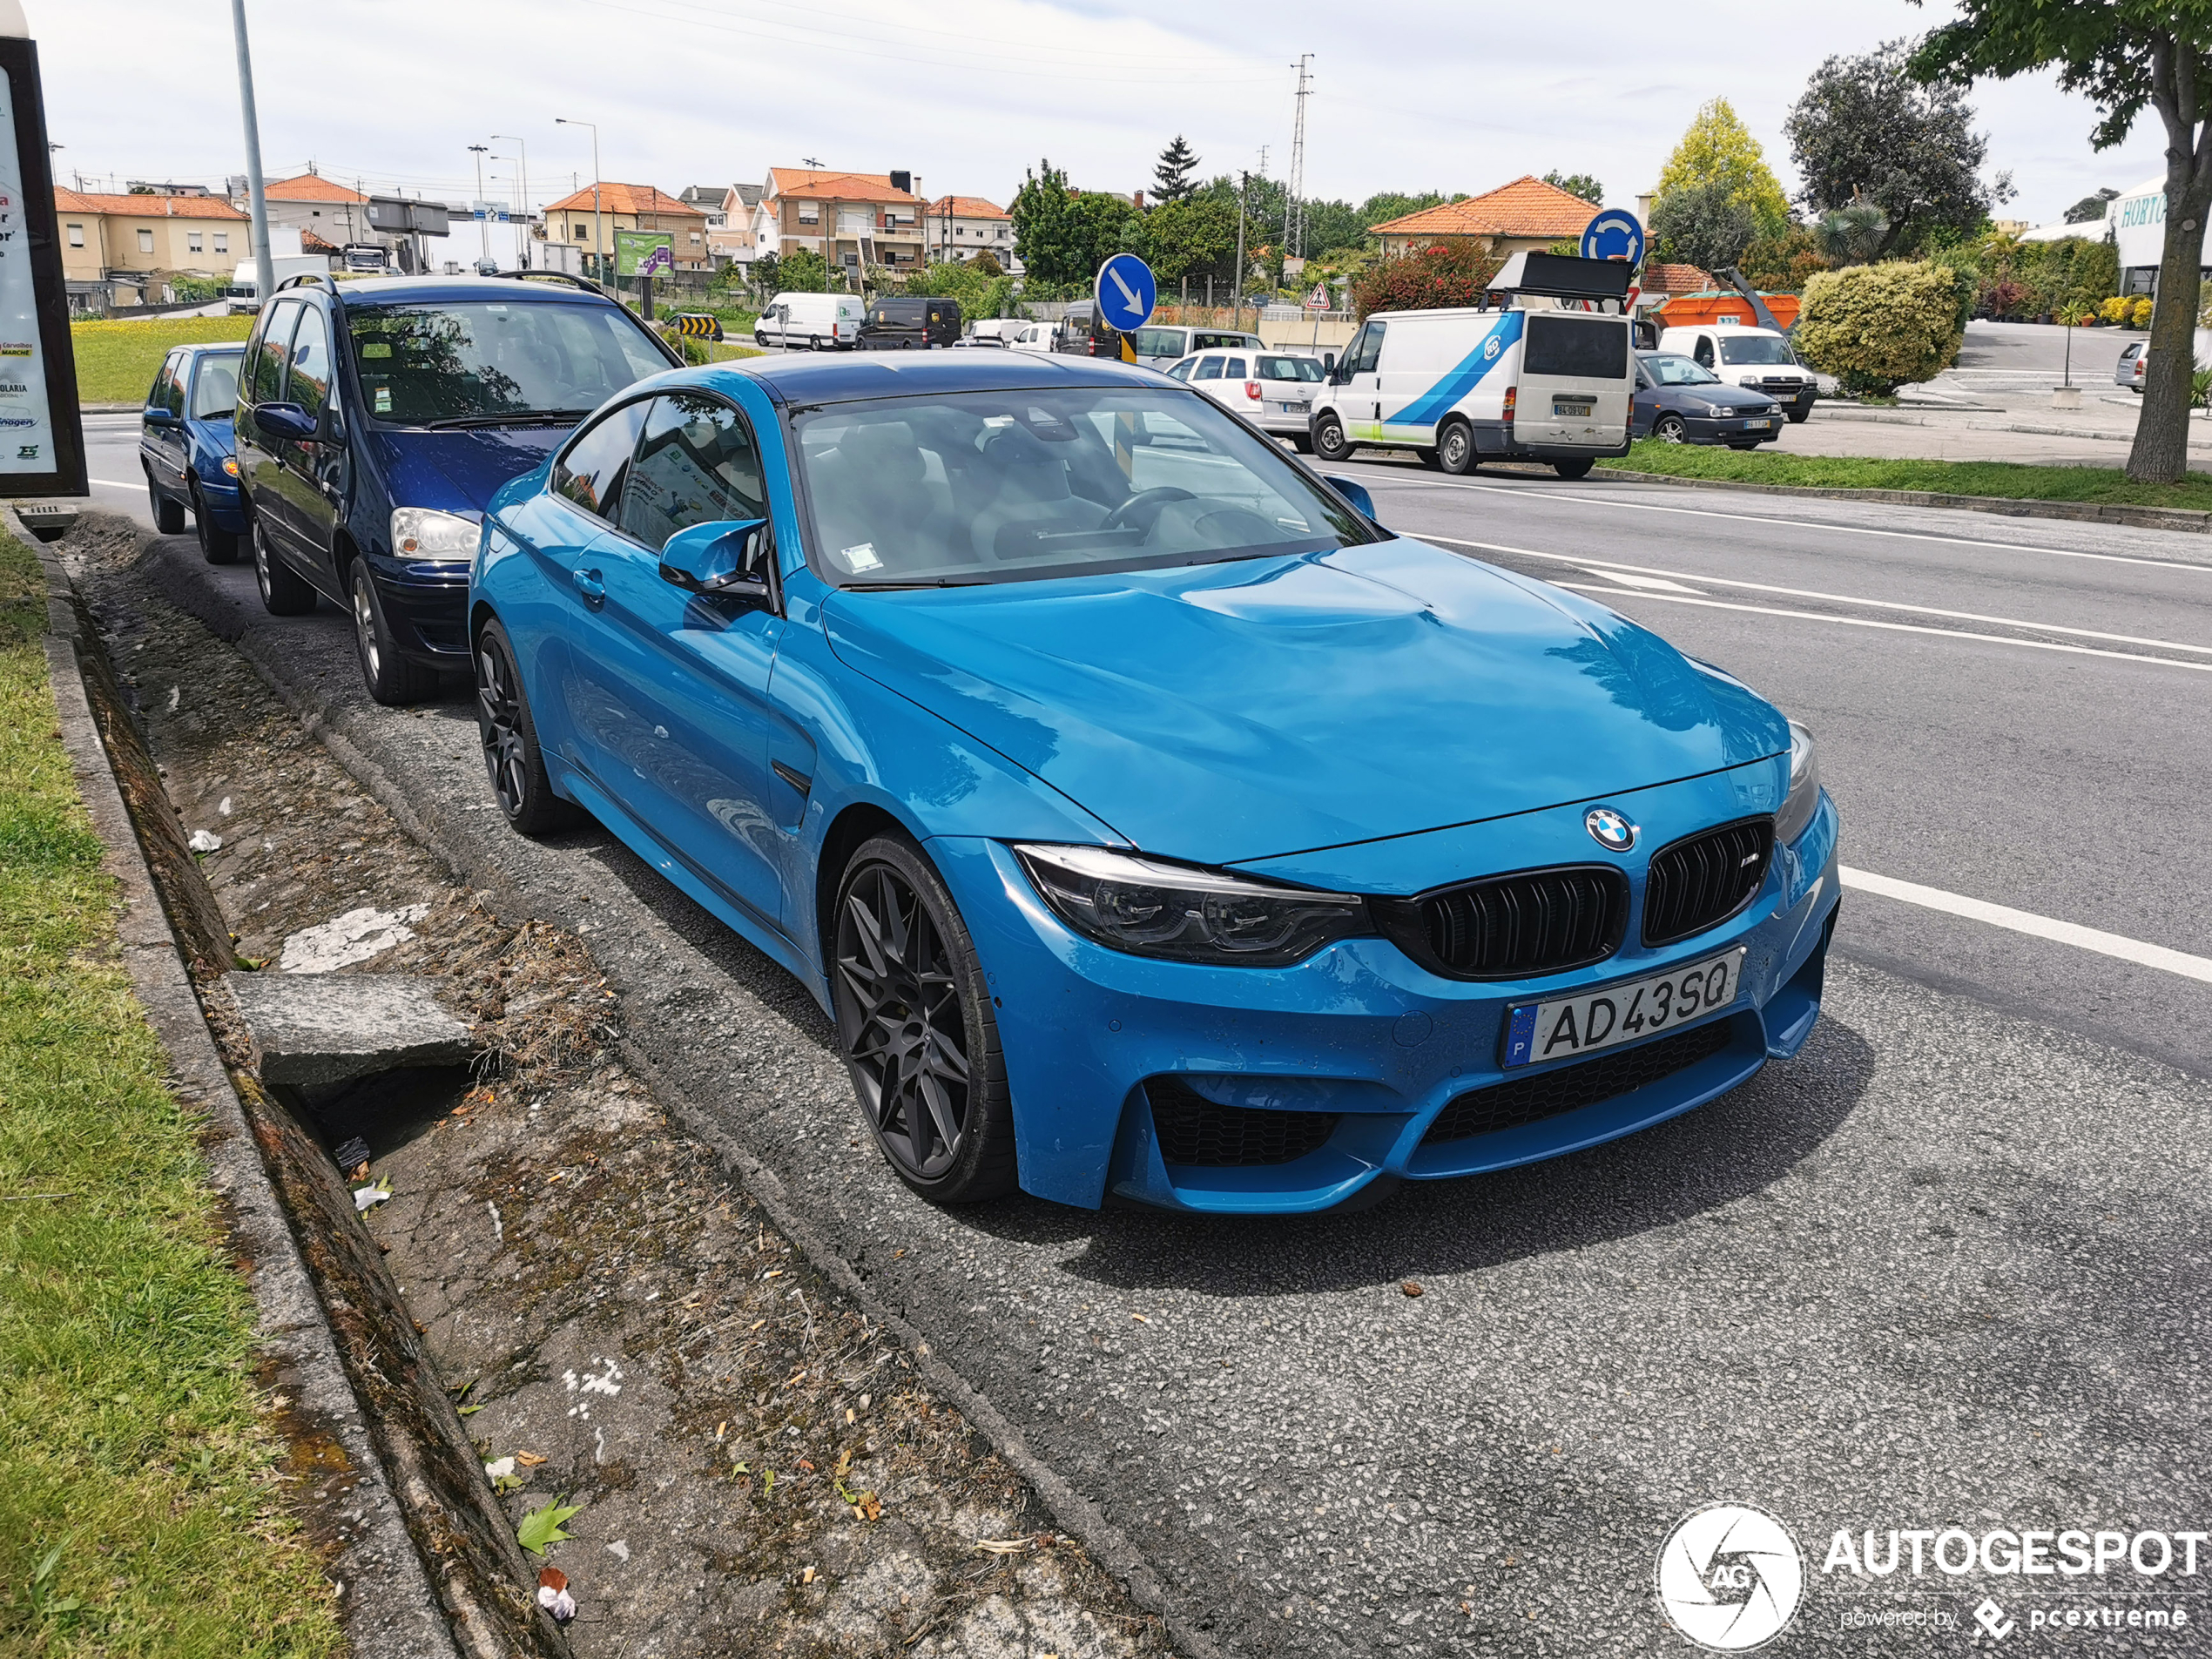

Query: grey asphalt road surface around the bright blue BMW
<box><xmin>78</xmin><ymin>464</ymin><xmax>2212</xmax><ymax>1655</ymax></box>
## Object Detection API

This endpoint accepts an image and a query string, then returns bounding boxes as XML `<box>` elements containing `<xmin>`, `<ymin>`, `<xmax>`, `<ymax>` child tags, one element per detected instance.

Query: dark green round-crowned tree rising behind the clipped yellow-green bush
<box><xmin>1783</xmin><ymin>40</ymin><xmax>2013</xmax><ymax>259</ymax></box>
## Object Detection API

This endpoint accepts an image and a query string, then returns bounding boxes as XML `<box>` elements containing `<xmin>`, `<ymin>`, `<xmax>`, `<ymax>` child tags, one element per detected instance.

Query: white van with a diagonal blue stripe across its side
<box><xmin>1312</xmin><ymin>302</ymin><xmax>1635</xmax><ymax>478</ymax></box>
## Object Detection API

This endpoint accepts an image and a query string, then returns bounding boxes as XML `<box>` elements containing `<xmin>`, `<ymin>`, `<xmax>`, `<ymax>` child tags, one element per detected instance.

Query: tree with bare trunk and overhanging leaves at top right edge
<box><xmin>1913</xmin><ymin>0</ymin><xmax>2212</xmax><ymax>484</ymax></box>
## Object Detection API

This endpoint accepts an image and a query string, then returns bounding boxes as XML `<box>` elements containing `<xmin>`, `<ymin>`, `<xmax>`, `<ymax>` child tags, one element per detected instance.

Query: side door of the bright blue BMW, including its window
<box><xmin>589</xmin><ymin>389</ymin><xmax>796</xmax><ymax>931</ymax></box>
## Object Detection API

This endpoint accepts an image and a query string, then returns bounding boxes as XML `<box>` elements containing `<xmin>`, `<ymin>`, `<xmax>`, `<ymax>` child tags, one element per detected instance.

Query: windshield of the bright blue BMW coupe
<box><xmin>792</xmin><ymin>388</ymin><xmax>1380</xmax><ymax>589</ymax></box>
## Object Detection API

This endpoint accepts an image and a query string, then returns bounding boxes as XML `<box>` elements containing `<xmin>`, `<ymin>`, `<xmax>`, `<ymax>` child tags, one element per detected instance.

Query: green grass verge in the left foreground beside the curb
<box><xmin>0</xmin><ymin>535</ymin><xmax>343</xmax><ymax>1659</ymax></box>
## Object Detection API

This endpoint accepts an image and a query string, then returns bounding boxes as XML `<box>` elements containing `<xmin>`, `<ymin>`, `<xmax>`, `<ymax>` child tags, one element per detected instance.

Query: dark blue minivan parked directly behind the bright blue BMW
<box><xmin>237</xmin><ymin>274</ymin><xmax>677</xmax><ymax>704</ymax></box>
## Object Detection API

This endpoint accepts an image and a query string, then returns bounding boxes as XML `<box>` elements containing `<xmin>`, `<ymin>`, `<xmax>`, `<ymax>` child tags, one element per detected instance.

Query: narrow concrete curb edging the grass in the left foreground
<box><xmin>21</xmin><ymin>511</ymin><xmax>460</xmax><ymax>1659</ymax></box>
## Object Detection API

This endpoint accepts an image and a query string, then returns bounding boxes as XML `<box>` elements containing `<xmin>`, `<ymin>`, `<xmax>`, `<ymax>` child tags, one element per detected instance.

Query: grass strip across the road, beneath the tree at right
<box><xmin>1597</xmin><ymin>438</ymin><xmax>2212</xmax><ymax>511</ymax></box>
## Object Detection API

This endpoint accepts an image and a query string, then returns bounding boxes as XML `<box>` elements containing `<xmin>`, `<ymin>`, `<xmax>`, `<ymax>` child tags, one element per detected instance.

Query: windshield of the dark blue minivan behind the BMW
<box><xmin>347</xmin><ymin>300</ymin><xmax>668</xmax><ymax>427</ymax></box>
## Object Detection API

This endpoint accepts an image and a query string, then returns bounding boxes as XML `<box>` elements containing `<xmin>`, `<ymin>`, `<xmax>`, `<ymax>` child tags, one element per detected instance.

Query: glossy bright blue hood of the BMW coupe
<box><xmin>825</xmin><ymin>537</ymin><xmax>1790</xmax><ymax>863</ymax></box>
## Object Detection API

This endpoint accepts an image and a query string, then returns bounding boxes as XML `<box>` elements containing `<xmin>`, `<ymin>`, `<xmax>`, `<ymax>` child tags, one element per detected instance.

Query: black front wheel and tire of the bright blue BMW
<box><xmin>830</xmin><ymin>834</ymin><xmax>1015</xmax><ymax>1204</ymax></box>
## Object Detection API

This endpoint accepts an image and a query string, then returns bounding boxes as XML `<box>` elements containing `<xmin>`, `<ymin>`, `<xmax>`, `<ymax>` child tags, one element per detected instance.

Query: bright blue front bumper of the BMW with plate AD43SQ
<box><xmin>929</xmin><ymin>781</ymin><xmax>1838</xmax><ymax>1212</ymax></box>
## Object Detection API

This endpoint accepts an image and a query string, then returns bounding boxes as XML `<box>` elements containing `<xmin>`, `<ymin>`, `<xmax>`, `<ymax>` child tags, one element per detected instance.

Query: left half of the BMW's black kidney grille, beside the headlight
<box><xmin>1373</xmin><ymin>865</ymin><xmax>1628</xmax><ymax>980</ymax></box>
